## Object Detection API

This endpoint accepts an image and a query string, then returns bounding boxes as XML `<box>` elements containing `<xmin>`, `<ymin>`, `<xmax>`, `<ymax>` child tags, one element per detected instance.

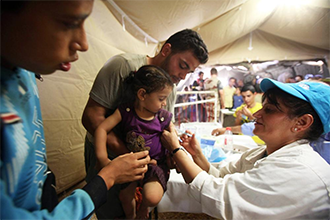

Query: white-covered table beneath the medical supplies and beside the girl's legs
<box><xmin>157</xmin><ymin>135</ymin><xmax>258</xmax><ymax>213</ymax></box>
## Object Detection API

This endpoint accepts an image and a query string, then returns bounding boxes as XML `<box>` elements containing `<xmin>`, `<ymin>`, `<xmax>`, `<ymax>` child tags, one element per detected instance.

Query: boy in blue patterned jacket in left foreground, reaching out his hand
<box><xmin>0</xmin><ymin>0</ymin><xmax>150</xmax><ymax>220</ymax></box>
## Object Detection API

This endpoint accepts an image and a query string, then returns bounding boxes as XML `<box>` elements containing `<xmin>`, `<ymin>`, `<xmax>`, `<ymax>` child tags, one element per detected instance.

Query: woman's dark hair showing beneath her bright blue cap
<box><xmin>262</xmin><ymin>87</ymin><xmax>323</xmax><ymax>141</ymax></box>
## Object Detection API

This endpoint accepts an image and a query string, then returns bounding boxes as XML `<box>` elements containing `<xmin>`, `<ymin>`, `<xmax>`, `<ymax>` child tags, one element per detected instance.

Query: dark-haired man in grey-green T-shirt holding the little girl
<box><xmin>82</xmin><ymin>29</ymin><xmax>208</xmax><ymax>220</ymax></box>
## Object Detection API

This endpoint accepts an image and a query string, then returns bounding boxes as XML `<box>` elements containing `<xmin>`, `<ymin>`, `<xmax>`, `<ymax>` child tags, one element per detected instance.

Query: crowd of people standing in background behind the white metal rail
<box><xmin>175</xmin><ymin>67</ymin><xmax>323</xmax><ymax>124</ymax></box>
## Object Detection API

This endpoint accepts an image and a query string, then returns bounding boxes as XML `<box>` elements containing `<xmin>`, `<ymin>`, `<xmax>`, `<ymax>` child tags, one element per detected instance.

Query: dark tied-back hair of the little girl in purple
<box><xmin>124</xmin><ymin>65</ymin><xmax>173</xmax><ymax>102</ymax></box>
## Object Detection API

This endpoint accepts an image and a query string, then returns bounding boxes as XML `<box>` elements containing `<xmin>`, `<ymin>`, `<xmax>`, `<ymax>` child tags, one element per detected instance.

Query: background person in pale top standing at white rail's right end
<box><xmin>204</xmin><ymin>67</ymin><xmax>225</xmax><ymax>122</ymax></box>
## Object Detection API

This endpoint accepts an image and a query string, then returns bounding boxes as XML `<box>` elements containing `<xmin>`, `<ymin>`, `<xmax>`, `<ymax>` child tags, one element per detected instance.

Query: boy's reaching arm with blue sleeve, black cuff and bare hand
<box><xmin>0</xmin><ymin>151</ymin><xmax>150</xmax><ymax>220</ymax></box>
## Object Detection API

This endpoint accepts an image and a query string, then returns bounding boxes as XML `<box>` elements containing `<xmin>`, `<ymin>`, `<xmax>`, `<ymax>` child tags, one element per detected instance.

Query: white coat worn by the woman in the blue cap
<box><xmin>188</xmin><ymin>140</ymin><xmax>330</xmax><ymax>220</ymax></box>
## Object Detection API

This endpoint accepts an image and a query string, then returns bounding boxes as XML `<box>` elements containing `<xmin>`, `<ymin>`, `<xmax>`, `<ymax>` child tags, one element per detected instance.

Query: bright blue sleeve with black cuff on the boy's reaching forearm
<box><xmin>0</xmin><ymin>173</ymin><xmax>107</xmax><ymax>220</ymax></box>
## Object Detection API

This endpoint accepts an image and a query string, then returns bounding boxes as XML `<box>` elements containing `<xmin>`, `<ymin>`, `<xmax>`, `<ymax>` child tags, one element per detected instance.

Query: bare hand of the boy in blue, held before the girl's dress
<box><xmin>98</xmin><ymin>151</ymin><xmax>150</xmax><ymax>189</ymax></box>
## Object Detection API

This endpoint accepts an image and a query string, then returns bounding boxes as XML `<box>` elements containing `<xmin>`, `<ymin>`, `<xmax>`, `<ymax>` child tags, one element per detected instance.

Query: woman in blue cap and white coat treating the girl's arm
<box><xmin>162</xmin><ymin>79</ymin><xmax>330</xmax><ymax>219</ymax></box>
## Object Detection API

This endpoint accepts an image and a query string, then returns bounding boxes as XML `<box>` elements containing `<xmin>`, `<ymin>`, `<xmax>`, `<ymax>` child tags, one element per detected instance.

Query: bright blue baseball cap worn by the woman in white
<box><xmin>260</xmin><ymin>79</ymin><xmax>330</xmax><ymax>133</ymax></box>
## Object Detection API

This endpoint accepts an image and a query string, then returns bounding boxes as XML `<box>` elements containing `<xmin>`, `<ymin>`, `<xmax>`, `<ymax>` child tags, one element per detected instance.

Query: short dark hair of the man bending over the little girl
<box><xmin>165</xmin><ymin>29</ymin><xmax>209</xmax><ymax>64</ymax></box>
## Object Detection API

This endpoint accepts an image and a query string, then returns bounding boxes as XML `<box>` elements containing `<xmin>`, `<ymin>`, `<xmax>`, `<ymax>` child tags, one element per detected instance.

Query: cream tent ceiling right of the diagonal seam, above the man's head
<box><xmin>104</xmin><ymin>0</ymin><xmax>330</xmax><ymax>65</ymax></box>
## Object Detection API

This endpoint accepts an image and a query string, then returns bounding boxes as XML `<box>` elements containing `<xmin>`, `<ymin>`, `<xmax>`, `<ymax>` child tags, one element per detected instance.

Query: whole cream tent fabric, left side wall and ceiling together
<box><xmin>38</xmin><ymin>0</ymin><xmax>330</xmax><ymax>192</ymax></box>
